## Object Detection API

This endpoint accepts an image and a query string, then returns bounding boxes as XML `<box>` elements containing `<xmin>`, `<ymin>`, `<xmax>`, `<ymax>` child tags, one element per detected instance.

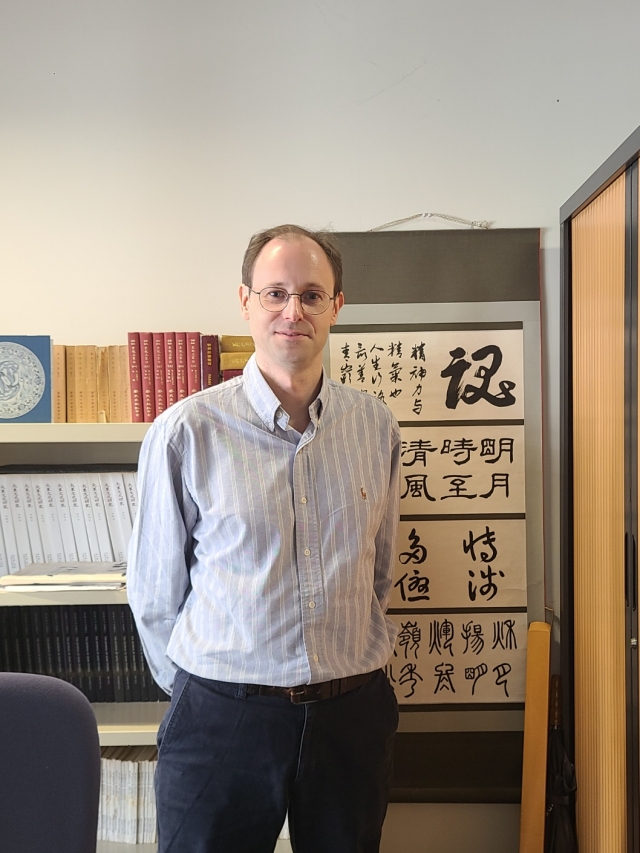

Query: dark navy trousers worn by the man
<box><xmin>156</xmin><ymin>670</ymin><xmax>398</xmax><ymax>853</ymax></box>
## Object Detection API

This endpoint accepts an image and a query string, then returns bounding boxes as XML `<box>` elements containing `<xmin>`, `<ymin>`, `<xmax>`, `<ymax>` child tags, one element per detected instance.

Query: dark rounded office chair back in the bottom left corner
<box><xmin>0</xmin><ymin>672</ymin><xmax>100</xmax><ymax>853</ymax></box>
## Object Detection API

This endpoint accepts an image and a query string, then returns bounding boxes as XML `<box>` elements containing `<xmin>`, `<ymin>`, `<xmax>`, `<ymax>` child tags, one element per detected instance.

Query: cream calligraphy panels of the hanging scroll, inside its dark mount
<box><xmin>330</xmin><ymin>323</ymin><xmax>527</xmax><ymax>707</ymax></box>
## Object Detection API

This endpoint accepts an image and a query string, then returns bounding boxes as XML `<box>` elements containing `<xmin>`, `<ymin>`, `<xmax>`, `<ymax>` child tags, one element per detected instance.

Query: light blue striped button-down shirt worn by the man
<box><xmin>127</xmin><ymin>357</ymin><xmax>400</xmax><ymax>692</ymax></box>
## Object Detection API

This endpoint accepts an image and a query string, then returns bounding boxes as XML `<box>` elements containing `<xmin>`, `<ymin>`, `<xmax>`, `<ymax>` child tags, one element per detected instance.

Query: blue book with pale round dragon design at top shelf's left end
<box><xmin>0</xmin><ymin>335</ymin><xmax>51</xmax><ymax>424</ymax></box>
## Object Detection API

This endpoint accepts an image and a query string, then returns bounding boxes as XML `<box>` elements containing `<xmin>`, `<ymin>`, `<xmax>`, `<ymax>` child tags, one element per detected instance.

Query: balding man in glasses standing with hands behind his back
<box><xmin>128</xmin><ymin>225</ymin><xmax>400</xmax><ymax>853</ymax></box>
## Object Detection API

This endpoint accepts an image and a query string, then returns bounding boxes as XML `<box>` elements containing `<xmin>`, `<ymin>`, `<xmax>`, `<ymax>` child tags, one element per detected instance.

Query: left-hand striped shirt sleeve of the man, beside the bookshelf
<box><xmin>127</xmin><ymin>420</ymin><xmax>197</xmax><ymax>694</ymax></box>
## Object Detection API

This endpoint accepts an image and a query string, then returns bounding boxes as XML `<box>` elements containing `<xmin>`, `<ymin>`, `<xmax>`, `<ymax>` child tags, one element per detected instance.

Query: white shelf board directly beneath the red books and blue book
<box><xmin>0</xmin><ymin>423</ymin><xmax>151</xmax><ymax>444</ymax></box>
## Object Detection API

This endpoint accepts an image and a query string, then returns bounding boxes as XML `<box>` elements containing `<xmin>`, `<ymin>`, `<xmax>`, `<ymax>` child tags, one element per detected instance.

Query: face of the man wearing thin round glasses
<box><xmin>240</xmin><ymin>237</ymin><xmax>344</xmax><ymax>372</ymax></box>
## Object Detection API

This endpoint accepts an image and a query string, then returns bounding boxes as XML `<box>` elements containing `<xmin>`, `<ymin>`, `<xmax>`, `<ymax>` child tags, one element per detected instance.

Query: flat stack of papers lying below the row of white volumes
<box><xmin>0</xmin><ymin>561</ymin><xmax>127</xmax><ymax>592</ymax></box>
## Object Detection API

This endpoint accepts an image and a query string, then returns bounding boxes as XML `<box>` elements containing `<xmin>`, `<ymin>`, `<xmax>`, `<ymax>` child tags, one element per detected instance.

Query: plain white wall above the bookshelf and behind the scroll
<box><xmin>0</xmin><ymin>0</ymin><xmax>640</xmax><ymax>716</ymax></box>
